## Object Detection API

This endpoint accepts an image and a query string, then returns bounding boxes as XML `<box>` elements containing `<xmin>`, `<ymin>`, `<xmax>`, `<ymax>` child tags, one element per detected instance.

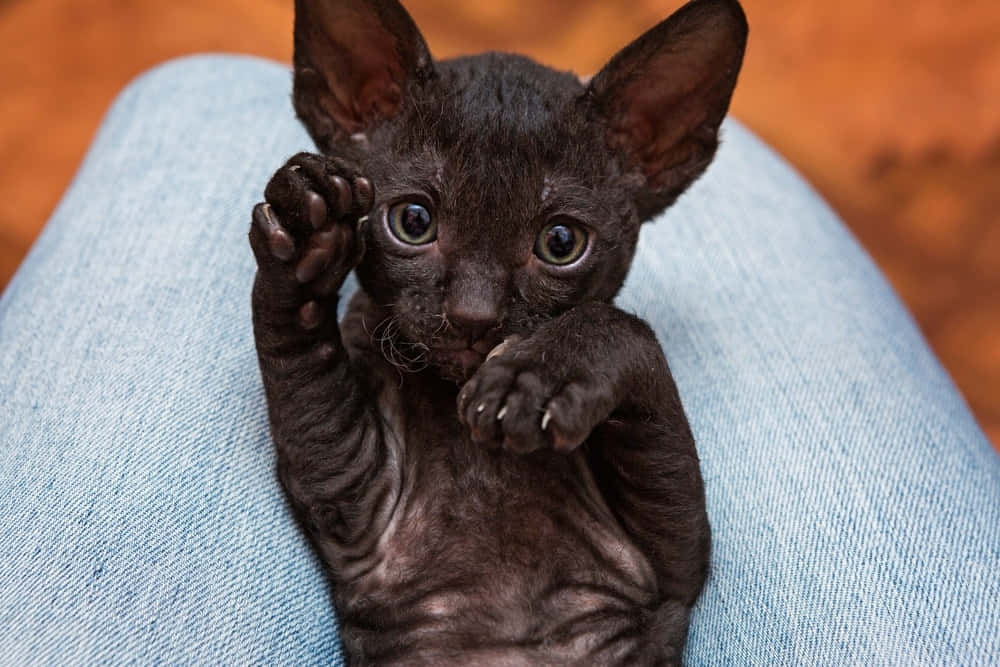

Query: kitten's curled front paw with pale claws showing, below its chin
<box><xmin>458</xmin><ymin>338</ymin><xmax>617</xmax><ymax>453</ymax></box>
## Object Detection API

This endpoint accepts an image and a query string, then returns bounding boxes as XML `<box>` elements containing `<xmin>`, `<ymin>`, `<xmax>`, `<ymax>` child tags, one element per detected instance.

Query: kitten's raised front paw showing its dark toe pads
<box><xmin>250</xmin><ymin>153</ymin><xmax>374</xmax><ymax>329</ymax></box>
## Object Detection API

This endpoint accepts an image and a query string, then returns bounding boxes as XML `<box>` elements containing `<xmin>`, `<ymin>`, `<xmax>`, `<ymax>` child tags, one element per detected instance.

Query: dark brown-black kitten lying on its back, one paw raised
<box><xmin>250</xmin><ymin>0</ymin><xmax>748</xmax><ymax>665</ymax></box>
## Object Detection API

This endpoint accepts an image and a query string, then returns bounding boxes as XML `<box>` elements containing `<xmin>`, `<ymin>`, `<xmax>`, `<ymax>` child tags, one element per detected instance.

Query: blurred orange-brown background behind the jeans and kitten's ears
<box><xmin>0</xmin><ymin>0</ymin><xmax>1000</xmax><ymax>447</ymax></box>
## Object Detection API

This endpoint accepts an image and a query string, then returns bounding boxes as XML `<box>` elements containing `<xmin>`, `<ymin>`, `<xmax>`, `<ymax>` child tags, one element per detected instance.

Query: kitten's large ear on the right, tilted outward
<box><xmin>587</xmin><ymin>0</ymin><xmax>748</xmax><ymax>220</ymax></box>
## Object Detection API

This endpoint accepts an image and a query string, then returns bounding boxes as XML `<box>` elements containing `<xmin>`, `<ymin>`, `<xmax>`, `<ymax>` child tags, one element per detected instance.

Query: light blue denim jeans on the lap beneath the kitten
<box><xmin>0</xmin><ymin>57</ymin><xmax>1000</xmax><ymax>665</ymax></box>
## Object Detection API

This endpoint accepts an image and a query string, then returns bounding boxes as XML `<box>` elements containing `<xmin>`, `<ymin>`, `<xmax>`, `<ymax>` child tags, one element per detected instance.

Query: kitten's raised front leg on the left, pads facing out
<box><xmin>250</xmin><ymin>153</ymin><xmax>398</xmax><ymax>578</ymax></box>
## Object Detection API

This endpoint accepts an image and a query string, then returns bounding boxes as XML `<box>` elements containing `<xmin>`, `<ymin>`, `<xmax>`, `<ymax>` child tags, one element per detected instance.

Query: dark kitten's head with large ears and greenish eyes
<box><xmin>294</xmin><ymin>0</ymin><xmax>747</xmax><ymax>379</ymax></box>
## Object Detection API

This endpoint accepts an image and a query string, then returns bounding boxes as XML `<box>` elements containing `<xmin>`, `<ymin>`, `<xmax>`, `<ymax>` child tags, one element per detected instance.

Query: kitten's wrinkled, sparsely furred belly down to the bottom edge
<box><xmin>337</xmin><ymin>440</ymin><xmax>656</xmax><ymax>665</ymax></box>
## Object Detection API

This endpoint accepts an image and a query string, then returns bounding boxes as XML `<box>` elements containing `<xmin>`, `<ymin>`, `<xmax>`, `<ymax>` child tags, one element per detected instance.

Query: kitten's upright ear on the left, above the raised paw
<box><xmin>293</xmin><ymin>0</ymin><xmax>434</xmax><ymax>149</ymax></box>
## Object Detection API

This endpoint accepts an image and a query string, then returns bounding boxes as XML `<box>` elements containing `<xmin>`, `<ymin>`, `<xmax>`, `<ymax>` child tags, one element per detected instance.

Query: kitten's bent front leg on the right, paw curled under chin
<box><xmin>458</xmin><ymin>303</ymin><xmax>710</xmax><ymax>659</ymax></box>
